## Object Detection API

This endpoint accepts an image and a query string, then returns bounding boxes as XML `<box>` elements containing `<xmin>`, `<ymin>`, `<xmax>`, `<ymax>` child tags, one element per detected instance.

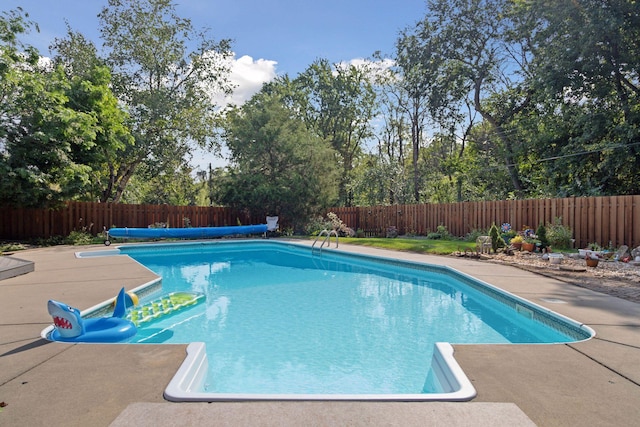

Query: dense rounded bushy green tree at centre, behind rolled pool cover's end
<box><xmin>218</xmin><ymin>83</ymin><xmax>337</xmax><ymax>227</ymax></box>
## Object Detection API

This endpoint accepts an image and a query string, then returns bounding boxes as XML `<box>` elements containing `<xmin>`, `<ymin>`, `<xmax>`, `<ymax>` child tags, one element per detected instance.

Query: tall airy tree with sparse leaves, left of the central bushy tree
<box><xmin>98</xmin><ymin>0</ymin><xmax>231</xmax><ymax>202</ymax></box>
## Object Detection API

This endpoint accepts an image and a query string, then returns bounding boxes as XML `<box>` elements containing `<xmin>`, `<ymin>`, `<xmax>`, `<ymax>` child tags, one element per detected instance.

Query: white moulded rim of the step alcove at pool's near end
<box><xmin>164</xmin><ymin>342</ymin><xmax>476</xmax><ymax>402</ymax></box>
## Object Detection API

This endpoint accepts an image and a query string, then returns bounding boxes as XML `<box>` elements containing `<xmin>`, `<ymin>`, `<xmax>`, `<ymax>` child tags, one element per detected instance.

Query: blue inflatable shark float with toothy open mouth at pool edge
<box><xmin>47</xmin><ymin>288</ymin><xmax>138</xmax><ymax>343</ymax></box>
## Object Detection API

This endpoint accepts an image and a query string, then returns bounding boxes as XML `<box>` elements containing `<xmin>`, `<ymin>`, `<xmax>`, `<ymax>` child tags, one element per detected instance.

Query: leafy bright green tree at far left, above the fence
<box><xmin>0</xmin><ymin>6</ymin><xmax>112</xmax><ymax>207</ymax></box>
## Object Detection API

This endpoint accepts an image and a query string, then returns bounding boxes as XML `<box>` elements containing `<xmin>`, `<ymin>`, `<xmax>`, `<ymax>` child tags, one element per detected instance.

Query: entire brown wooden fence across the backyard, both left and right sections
<box><xmin>0</xmin><ymin>196</ymin><xmax>640</xmax><ymax>247</ymax></box>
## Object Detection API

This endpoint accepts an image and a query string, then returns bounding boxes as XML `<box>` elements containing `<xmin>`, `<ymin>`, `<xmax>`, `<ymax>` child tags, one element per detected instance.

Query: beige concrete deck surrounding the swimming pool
<box><xmin>0</xmin><ymin>241</ymin><xmax>640</xmax><ymax>426</ymax></box>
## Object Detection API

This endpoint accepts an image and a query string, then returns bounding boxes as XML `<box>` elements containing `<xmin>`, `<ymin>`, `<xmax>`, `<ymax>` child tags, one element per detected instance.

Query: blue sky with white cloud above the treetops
<box><xmin>7</xmin><ymin>0</ymin><xmax>426</xmax><ymax>169</ymax></box>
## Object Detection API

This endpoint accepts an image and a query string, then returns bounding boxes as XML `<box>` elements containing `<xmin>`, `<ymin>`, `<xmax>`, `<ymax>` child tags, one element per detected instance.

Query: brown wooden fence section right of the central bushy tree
<box><xmin>329</xmin><ymin>196</ymin><xmax>640</xmax><ymax>248</ymax></box>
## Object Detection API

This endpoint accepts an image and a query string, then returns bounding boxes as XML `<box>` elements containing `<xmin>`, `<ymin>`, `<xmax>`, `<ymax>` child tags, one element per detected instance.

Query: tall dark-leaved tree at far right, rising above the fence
<box><xmin>518</xmin><ymin>0</ymin><xmax>640</xmax><ymax>196</ymax></box>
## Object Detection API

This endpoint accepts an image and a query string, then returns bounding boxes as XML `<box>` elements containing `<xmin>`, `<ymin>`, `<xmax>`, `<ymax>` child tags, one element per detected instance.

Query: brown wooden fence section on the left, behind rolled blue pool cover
<box><xmin>0</xmin><ymin>202</ymin><xmax>266</xmax><ymax>240</ymax></box>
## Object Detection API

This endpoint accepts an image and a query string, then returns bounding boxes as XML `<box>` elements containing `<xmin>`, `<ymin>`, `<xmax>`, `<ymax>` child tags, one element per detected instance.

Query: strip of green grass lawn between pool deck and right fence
<box><xmin>328</xmin><ymin>237</ymin><xmax>476</xmax><ymax>255</ymax></box>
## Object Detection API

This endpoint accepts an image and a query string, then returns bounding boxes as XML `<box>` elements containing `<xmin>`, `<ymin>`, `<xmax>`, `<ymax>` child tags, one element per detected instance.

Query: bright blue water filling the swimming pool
<box><xmin>121</xmin><ymin>241</ymin><xmax>586</xmax><ymax>394</ymax></box>
